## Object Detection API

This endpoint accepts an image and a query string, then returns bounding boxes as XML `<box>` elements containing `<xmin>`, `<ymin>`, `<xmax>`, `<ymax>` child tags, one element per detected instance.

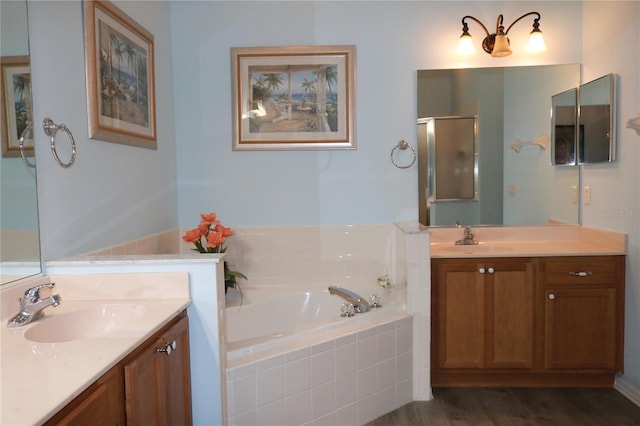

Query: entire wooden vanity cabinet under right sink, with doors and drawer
<box><xmin>431</xmin><ymin>256</ymin><xmax>625</xmax><ymax>386</ymax></box>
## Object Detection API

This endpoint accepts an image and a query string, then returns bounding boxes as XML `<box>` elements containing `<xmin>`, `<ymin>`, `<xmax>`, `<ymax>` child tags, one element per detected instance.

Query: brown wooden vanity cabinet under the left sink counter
<box><xmin>45</xmin><ymin>311</ymin><xmax>192</xmax><ymax>426</ymax></box>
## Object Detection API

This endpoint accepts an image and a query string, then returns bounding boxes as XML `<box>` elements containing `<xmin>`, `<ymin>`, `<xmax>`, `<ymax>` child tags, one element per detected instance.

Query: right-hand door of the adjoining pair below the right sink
<box><xmin>484</xmin><ymin>260</ymin><xmax>534</xmax><ymax>368</ymax></box>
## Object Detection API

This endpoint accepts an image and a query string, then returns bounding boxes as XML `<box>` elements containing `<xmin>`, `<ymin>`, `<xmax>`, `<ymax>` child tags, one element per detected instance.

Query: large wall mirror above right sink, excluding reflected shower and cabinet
<box><xmin>417</xmin><ymin>64</ymin><xmax>581</xmax><ymax>227</ymax></box>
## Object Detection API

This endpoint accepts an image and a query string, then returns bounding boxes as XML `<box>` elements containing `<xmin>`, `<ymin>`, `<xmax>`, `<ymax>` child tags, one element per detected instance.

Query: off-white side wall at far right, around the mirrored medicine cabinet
<box><xmin>582</xmin><ymin>1</ymin><xmax>640</xmax><ymax>402</ymax></box>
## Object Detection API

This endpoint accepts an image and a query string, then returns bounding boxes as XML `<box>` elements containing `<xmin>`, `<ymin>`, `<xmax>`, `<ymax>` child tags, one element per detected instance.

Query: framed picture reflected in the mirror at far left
<box><xmin>0</xmin><ymin>56</ymin><xmax>34</xmax><ymax>157</ymax></box>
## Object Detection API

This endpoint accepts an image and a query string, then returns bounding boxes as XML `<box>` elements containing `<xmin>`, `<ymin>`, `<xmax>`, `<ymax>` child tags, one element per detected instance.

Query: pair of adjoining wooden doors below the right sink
<box><xmin>432</xmin><ymin>258</ymin><xmax>535</xmax><ymax>376</ymax></box>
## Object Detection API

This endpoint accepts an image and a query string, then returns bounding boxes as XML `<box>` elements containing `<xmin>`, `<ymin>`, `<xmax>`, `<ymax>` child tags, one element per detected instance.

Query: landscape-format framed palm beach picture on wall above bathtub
<box><xmin>231</xmin><ymin>45</ymin><xmax>356</xmax><ymax>151</ymax></box>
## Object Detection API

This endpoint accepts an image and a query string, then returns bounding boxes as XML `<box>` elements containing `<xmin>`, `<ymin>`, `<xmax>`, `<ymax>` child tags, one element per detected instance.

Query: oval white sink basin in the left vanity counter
<box><xmin>24</xmin><ymin>303</ymin><xmax>144</xmax><ymax>343</ymax></box>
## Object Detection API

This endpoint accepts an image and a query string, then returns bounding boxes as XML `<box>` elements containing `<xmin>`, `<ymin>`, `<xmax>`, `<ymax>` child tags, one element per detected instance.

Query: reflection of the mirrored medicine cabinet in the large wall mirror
<box><xmin>551</xmin><ymin>88</ymin><xmax>582</xmax><ymax>166</ymax></box>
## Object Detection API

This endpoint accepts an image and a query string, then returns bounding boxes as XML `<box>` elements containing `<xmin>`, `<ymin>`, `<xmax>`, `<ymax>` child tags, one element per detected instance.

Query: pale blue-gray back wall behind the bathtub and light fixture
<box><xmin>171</xmin><ymin>1</ymin><xmax>581</xmax><ymax>227</ymax></box>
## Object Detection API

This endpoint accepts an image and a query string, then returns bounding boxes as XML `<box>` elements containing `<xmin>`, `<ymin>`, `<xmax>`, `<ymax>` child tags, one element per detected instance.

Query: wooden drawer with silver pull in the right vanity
<box><xmin>544</xmin><ymin>256</ymin><xmax>620</xmax><ymax>285</ymax></box>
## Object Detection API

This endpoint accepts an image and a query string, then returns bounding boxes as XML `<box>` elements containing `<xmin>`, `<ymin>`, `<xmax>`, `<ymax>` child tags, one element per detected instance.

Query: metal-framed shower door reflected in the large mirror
<box><xmin>418</xmin><ymin>117</ymin><xmax>479</xmax><ymax>225</ymax></box>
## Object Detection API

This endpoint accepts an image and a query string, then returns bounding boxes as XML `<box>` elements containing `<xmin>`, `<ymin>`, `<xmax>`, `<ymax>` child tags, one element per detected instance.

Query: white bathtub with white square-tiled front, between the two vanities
<box><xmin>226</xmin><ymin>284</ymin><xmax>413</xmax><ymax>426</ymax></box>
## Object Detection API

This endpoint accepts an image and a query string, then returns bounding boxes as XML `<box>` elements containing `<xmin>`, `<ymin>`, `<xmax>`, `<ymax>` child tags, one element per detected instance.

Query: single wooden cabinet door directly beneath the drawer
<box><xmin>545</xmin><ymin>288</ymin><xmax>618</xmax><ymax>371</ymax></box>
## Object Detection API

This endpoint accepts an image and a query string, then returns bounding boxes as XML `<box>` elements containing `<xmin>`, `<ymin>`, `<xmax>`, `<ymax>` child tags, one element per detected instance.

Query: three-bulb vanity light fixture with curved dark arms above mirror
<box><xmin>456</xmin><ymin>12</ymin><xmax>547</xmax><ymax>58</ymax></box>
